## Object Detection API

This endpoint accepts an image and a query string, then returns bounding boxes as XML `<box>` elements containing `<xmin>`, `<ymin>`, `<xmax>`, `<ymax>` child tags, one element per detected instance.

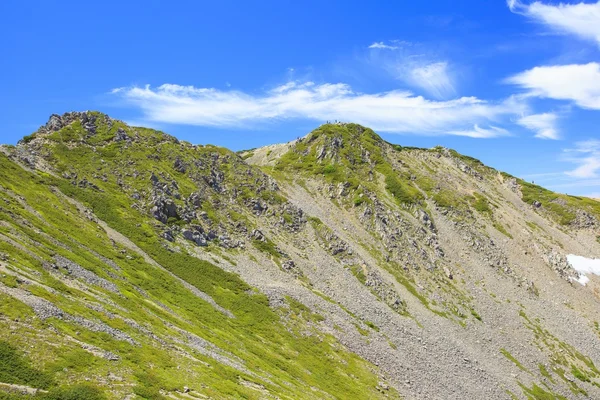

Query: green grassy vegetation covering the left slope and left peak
<box><xmin>0</xmin><ymin>119</ymin><xmax>394</xmax><ymax>399</ymax></box>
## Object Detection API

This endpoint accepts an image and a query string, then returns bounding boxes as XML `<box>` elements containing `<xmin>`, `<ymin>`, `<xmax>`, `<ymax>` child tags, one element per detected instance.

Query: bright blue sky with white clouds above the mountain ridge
<box><xmin>0</xmin><ymin>0</ymin><xmax>600</xmax><ymax>197</ymax></box>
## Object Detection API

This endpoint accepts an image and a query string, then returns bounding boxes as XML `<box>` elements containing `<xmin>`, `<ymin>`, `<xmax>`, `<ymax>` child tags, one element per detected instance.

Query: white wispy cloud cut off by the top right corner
<box><xmin>507</xmin><ymin>0</ymin><xmax>600</xmax><ymax>43</ymax></box>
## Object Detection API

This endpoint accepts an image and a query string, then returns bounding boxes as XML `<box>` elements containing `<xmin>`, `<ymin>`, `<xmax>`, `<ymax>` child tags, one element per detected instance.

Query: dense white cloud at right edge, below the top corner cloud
<box><xmin>506</xmin><ymin>62</ymin><xmax>600</xmax><ymax>110</ymax></box>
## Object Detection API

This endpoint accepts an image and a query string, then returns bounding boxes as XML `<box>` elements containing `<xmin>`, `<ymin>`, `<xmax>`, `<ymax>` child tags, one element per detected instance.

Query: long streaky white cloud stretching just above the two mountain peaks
<box><xmin>114</xmin><ymin>81</ymin><xmax>527</xmax><ymax>137</ymax></box>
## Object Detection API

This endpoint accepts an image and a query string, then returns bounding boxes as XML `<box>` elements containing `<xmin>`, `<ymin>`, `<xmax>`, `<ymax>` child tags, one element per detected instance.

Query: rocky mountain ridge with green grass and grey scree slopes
<box><xmin>0</xmin><ymin>112</ymin><xmax>600</xmax><ymax>399</ymax></box>
